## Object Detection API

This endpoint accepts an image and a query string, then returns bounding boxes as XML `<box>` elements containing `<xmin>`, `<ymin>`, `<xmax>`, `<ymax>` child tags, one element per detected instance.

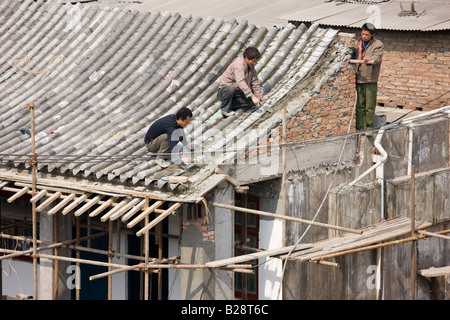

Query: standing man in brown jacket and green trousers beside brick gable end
<box><xmin>356</xmin><ymin>23</ymin><xmax>384</xmax><ymax>135</ymax></box>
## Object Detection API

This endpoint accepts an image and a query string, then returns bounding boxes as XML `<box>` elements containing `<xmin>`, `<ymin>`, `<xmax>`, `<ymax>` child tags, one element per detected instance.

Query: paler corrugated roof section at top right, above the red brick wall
<box><xmin>280</xmin><ymin>0</ymin><xmax>450</xmax><ymax>31</ymax></box>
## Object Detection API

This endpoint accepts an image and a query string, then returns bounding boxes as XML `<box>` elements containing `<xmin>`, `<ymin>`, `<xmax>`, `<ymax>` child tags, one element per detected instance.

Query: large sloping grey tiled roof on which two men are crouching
<box><xmin>0</xmin><ymin>1</ymin><xmax>346</xmax><ymax>198</ymax></box>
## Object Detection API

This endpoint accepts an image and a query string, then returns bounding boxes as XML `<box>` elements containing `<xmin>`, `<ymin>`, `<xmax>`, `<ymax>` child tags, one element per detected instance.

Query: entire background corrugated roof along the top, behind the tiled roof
<box><xmin>88</xmin><ymin>0</ymin><xmax>450</xmax><ymax>31</ymax></box>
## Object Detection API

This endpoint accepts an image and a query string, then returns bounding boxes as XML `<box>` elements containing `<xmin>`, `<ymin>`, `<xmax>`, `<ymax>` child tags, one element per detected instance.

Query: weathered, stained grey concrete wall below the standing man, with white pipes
<box><xmin>283</xmin><ymin>120</ymin><xmax>450</xmax><ymax>299</ymax></box>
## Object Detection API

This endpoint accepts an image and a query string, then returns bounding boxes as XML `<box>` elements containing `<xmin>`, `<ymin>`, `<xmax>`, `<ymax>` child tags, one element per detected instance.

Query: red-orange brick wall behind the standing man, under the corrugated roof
<box><xmin>342</xmin><ymin>29</ymin><xmax>450</xmax><ymax>111</ymax></box>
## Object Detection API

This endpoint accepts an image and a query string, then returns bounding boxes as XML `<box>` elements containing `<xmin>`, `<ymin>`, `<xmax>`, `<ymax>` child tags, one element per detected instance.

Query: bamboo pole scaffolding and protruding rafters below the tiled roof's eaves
<box><xmin>0</xmin><ymin>103</ymin><xmax>450</xmax><ymax>300</ymax></box>
